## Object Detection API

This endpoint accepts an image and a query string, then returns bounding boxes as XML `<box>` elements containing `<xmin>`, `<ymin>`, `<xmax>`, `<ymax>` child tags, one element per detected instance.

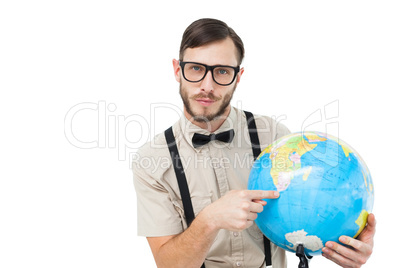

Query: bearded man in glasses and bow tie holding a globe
<box><xmin>133</xmin><ymin>19</ymin><xmax>375</xmax><ymax>268</ymax></box>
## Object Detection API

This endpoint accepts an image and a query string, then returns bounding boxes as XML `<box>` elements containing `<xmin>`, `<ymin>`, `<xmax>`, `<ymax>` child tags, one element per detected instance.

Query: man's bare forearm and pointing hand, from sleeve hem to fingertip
<box><xmin>147</xmin><ymin>190</ymin><xmax>279</xmax><ymax>268</ymax></box>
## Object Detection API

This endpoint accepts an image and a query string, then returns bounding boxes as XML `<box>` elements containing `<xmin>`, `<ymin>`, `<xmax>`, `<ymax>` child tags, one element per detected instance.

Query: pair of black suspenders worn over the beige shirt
<box><xmin>165</xmin><ymin>111</ymin><xmax>272</xmax><ymax>268</ymax></box>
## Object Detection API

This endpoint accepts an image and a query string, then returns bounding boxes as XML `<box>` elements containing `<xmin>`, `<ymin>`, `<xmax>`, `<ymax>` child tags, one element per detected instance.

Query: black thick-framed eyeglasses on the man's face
<box><xmin>180</xmin><ymin>61</ymin><xmax>240</xmax><ymax>86</ymax></box>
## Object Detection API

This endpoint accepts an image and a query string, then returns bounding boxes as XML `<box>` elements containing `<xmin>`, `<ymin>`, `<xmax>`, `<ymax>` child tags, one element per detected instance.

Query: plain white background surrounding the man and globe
<box><xmin>0</xmin><ymin>0</ymin><xmax>402</xmax><ymax>268</ymax></box>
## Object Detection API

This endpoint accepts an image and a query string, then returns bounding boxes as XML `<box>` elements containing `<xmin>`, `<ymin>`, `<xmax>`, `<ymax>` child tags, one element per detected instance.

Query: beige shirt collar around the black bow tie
<box><xmin>179</xmin><ymin>106</ymin><xmax>238</xmax><ymax>152</ymax></box>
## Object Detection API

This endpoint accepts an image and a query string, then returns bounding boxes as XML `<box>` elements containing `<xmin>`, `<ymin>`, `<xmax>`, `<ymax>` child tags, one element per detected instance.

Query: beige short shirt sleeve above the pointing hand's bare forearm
<box><xmin>132</xmin><ymin>143</ymin><xmax>183</xmax><ymax>237</ymax></box>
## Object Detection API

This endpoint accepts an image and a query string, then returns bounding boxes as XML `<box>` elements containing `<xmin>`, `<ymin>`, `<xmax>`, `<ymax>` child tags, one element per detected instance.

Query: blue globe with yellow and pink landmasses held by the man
<box><xmin>248</xmin><ymin>132</ymin><xmax>374</xmax><ymax>256</ymax></box>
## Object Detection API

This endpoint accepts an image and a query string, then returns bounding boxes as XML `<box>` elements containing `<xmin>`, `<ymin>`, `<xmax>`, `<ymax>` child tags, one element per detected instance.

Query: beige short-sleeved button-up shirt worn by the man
<box><xmin>133</xmin><ymin>107</ymin><xmax>290</xmax><ymax>268</ymax></box>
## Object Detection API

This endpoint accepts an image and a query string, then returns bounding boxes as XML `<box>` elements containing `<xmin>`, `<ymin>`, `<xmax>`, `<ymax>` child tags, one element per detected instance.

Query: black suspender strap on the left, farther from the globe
<box><xmin>165</xmin><ymin>127</ymin><xmax>205</xmax><ymax>268</ymax></box>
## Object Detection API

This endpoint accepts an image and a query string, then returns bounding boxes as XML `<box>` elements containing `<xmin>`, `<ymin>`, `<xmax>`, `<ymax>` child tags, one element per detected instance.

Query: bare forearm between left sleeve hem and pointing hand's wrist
<box><xmin>154</xmin><ymin>209</ymin><xmax>219</xmax><ymax>268</ymax></box>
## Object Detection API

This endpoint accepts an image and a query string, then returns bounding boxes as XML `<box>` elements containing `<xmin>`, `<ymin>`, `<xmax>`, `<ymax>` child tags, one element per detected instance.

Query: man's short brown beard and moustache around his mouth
<box><xmin>180</xmin><ymin>83</ymin><xmax>236</xmax><ymax>123</ymax></box>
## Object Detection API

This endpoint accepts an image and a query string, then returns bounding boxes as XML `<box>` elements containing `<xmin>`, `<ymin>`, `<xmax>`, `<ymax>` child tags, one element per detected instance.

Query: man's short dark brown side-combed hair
<box><xmin>179</xmin><ymin>19</ymin><xmax>244</xmax><ymax>65</ymax></box>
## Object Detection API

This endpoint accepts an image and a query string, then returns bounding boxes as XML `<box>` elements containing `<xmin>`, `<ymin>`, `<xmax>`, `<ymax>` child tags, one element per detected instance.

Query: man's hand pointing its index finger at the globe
<box><xmin>200</xmin><ymin>190</ymin><xmax>279</xmax><ymax>231</ymax></box>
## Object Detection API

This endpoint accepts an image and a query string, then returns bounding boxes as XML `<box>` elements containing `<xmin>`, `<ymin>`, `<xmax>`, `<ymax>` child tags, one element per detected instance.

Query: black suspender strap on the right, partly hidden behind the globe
<box><xmin>244</xmin><ymin>111</ymin><xmax>272</xmax><ymax>266</ymax></box>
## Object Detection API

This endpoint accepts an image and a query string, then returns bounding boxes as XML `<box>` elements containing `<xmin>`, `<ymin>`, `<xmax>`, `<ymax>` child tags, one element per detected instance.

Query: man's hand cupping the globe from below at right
<box><xmin>322</xmin><ymin>214</ymin><xmax>376</xmax><ymax>268</ymax></box>
